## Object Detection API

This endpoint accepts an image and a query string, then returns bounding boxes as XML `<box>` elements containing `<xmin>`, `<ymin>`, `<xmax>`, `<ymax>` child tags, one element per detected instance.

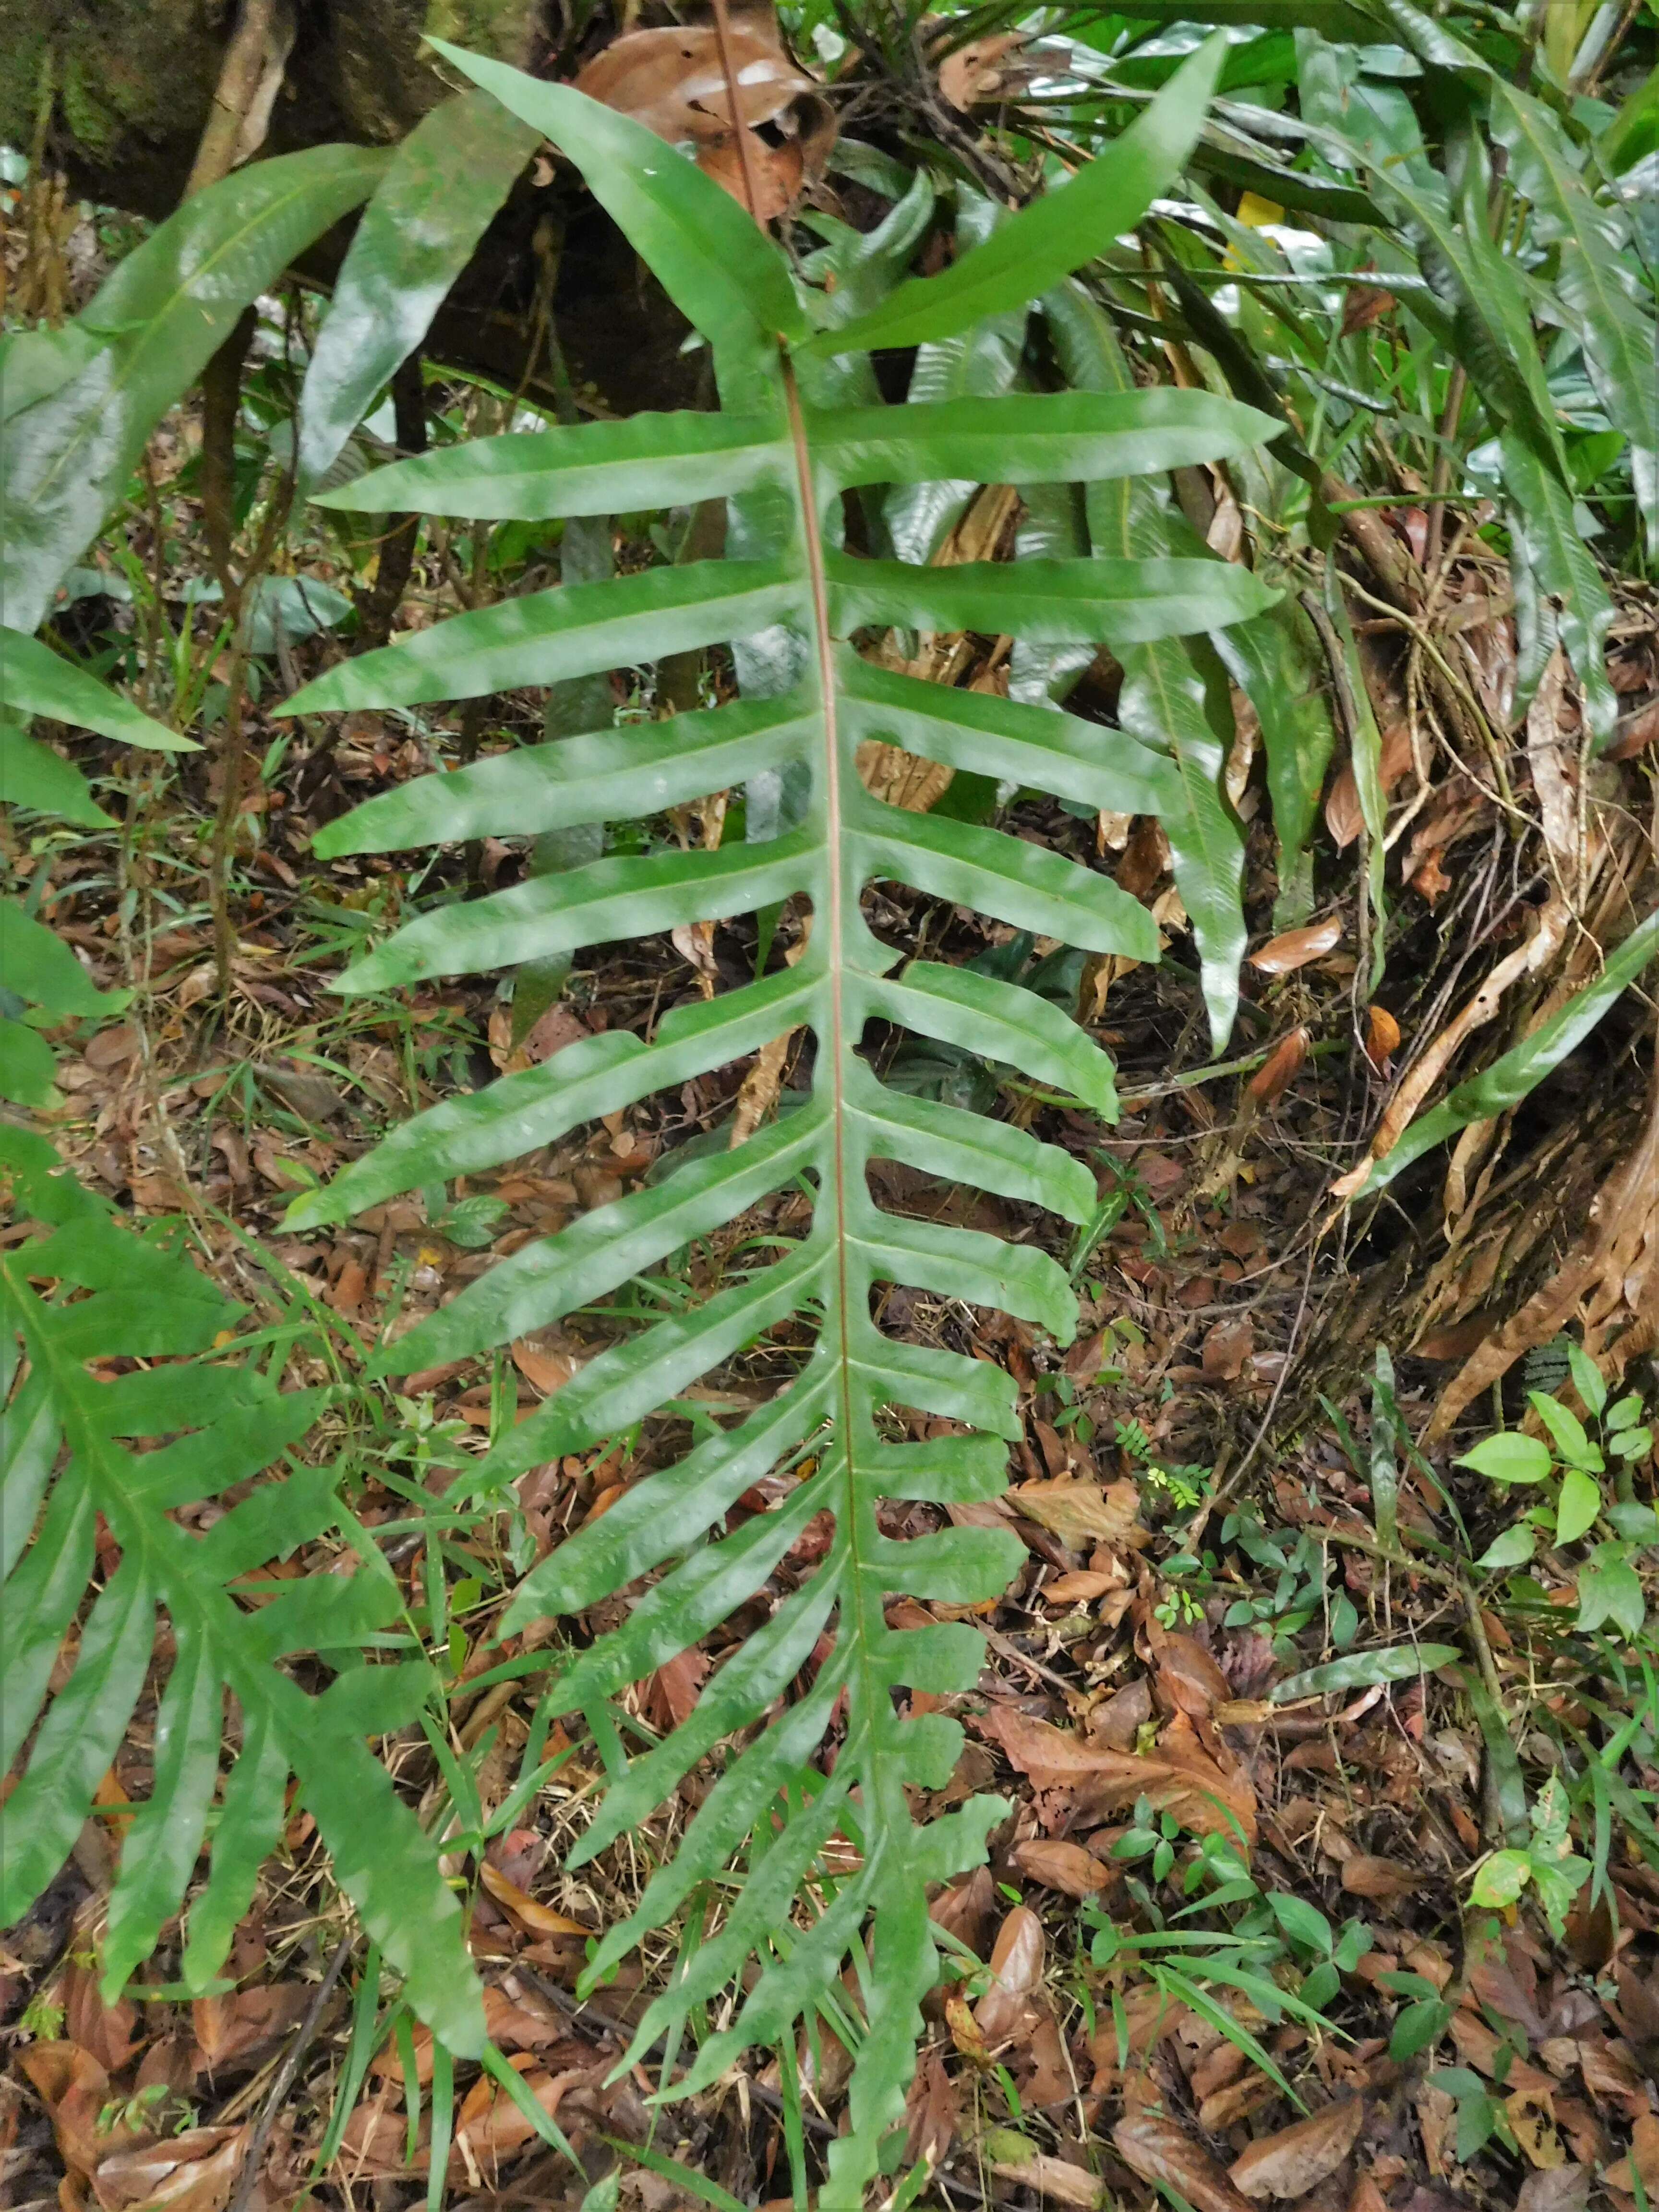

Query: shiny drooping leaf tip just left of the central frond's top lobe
<box><xmin>299</xmin><ymin>93</ymin><xmax>538</xmax><ymax>493</ymax></box>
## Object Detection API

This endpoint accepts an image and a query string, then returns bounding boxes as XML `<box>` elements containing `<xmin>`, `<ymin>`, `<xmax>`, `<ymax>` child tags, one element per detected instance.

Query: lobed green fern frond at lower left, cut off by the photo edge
<box><xmin>0</xmin><ymin>1126</ymin><xmax>484</xmax><ymax>2055</ymax></box>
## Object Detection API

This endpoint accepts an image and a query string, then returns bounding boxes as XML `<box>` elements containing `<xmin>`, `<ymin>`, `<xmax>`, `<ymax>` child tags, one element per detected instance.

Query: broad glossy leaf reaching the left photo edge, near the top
<box><xmin>0</xmin><ymin>146</ymin><xmax>389</xmax><ymax>632</ymax></box>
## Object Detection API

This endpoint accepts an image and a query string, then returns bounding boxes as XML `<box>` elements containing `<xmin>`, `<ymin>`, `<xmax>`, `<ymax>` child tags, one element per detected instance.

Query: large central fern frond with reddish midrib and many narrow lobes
<box><xmin>279</xmin><ymin>48</ymin><xmax>1270</xmax><ymax>2205</ymax></box>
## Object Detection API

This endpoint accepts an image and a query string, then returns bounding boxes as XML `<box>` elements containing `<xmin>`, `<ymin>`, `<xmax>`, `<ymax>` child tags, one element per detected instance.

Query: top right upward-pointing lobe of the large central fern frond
<box><xmin>803</xmin><ymin>37</ymin><xmax>1226</xmax><ymax>354</ymax></box>
